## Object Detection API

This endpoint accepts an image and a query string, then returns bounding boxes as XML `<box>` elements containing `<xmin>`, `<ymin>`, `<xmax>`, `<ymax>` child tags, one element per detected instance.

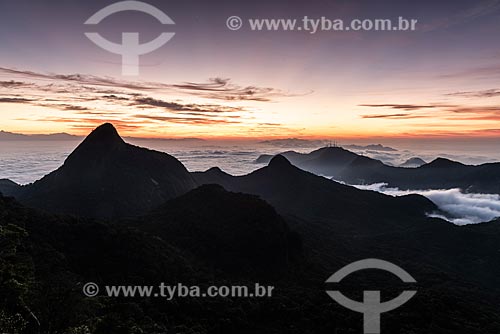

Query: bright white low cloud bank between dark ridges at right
<box><xmin>355</xmin><ymin>183</ymin><xmax>500</xmax><ymax>225</ymax></box>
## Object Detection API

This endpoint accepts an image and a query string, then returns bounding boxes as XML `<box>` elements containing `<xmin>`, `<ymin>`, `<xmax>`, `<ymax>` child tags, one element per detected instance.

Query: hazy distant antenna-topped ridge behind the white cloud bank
<box><xmin>260</xmin><ymin>147</ymin><xmax>500</xmax><ymax>194</ymax></box>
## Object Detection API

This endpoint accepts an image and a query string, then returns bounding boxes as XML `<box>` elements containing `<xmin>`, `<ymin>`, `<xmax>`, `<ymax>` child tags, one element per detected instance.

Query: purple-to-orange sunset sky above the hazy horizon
<box><xmin>0</xmin><ymin>0</ymin><xmax>500</xmax><ymax>139</ymax></box>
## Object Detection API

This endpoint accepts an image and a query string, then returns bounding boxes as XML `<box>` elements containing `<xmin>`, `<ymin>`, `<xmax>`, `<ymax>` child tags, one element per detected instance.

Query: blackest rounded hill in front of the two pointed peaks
<box><xmin>131</xmin><ymin>185</ymin><xmax>300</xmax><ymax>277</ymax></box>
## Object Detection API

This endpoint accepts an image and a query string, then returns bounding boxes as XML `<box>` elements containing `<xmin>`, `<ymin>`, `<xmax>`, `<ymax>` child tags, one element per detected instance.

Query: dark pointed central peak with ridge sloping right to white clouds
<box><xmin>194</xmin><ymin>155</ymin><xmax>437</xmax><ymax>231</ymax></box>
